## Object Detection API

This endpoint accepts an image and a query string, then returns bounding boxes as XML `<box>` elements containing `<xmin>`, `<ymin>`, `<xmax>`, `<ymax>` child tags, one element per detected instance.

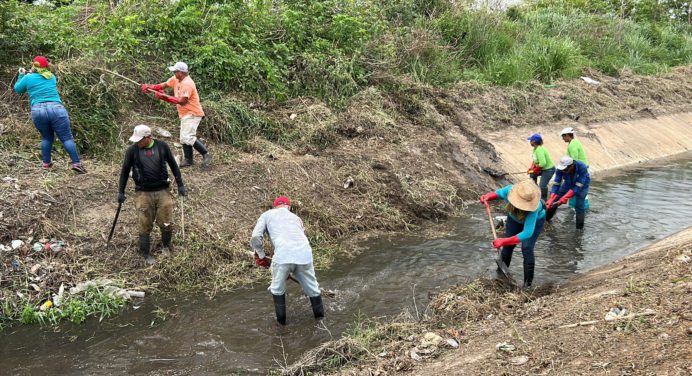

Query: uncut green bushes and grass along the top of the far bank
<box><xmin>0</xmin><ymin>0</ymin><xmax>692</xmax><ymax>155</ymax></box>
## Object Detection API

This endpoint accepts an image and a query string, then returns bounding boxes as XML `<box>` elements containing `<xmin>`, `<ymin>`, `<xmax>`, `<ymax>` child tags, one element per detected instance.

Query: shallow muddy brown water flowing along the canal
<box><xmin>0</xmin><ymin>155</ymin><xmax>692</xmax><ymax>375</ymax></box>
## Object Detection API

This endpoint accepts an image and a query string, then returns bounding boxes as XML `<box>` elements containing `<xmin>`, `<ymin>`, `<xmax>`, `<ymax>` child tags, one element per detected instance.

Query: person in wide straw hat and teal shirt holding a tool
<box><xmin>481</xmin><ymin>180</ymin><xmax>545</xmax><ymax>288</ymax></box>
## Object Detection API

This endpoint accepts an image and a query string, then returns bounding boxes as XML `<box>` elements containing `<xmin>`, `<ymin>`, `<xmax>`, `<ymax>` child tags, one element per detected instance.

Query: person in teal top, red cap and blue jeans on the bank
<box><xmin>14</xmin><ymin>56</ymin><xmax>86</xmax><ymax>174</ymax></box>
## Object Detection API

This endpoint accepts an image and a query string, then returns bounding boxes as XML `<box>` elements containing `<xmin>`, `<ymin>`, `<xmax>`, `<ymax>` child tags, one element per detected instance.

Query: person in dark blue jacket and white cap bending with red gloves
<box><xmin>546</xmin><ymin>155</ymin><xmax>591</xmax><ymax>230</ymax></box>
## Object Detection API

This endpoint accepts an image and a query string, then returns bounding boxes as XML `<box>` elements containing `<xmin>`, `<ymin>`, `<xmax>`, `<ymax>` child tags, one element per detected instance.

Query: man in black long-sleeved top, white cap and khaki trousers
<box><xmin>118</xmin><ymin>125</ymin><xmax>187</xmax><ymax>265</ymax></box>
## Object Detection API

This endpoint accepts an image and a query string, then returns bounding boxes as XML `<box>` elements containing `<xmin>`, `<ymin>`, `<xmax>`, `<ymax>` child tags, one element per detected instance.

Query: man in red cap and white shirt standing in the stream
<box><xmin>250</xmin><ymin>196</ymin><xmax>324</xmax><ymax>325</ymax></box>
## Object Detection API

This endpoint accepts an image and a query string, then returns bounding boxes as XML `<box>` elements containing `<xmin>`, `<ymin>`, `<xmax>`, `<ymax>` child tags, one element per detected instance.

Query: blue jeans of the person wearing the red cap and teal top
<box><xmin>31</xmin><ymin>102</ymin><xmax>79</xmax><ymax>163</ymax></box>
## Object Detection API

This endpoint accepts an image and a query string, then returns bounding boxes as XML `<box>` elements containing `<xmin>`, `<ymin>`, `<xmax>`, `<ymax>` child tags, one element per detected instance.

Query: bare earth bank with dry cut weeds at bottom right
<box><xmin>283</xmin><ymin>228</ymin><xmax>692</xmax><ymax>375</ymax></box>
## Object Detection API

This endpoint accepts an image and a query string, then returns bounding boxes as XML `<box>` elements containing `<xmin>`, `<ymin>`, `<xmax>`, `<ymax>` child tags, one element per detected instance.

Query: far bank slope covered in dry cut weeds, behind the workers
<box><xmin>0</xmin><ymin>68</ymin><xmax>692</xmax><ymax>324</ymax></box>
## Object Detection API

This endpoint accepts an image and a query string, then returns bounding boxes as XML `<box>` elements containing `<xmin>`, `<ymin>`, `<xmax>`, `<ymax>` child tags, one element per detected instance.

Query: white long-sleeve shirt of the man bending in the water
<box><xmin>250</xmin><ymin>206</ymin><xmax>312</xmax><ymax>265</ymax></box>
